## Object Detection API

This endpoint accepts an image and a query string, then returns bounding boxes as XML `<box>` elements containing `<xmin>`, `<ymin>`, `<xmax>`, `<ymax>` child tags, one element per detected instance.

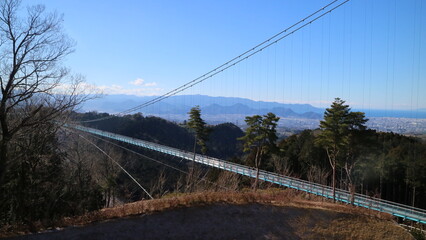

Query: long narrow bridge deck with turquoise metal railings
<box><xmin>65</xmin><ymin>124</ymin><xmax>426</xmax><ymax>224</ymax></box>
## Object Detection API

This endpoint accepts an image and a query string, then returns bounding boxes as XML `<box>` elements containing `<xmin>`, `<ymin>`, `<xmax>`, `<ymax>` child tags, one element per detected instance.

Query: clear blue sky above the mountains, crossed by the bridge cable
<box><xmin>31</xmin><ymin>0</ymin><xmax>426</xmax><ymax>110</ymax></box>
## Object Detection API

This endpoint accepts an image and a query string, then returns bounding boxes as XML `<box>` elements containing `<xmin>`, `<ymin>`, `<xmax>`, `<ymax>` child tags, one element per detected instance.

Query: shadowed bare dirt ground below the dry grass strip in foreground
<box><xmin>1</xmin><ymin>203</ymin><xmax>411</xmax><ymax>240</ymax></box>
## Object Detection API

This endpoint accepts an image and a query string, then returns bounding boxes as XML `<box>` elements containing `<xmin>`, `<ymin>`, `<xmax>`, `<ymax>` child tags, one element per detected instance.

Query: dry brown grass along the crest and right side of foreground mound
<box><xmin>0</xmin><ymin>189</ymin><xmax>404</xmax><ymax>239</ymax></box>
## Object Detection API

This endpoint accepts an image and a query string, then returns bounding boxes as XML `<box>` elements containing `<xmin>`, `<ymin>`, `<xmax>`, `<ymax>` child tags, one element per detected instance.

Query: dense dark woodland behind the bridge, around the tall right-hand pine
<box><xmin>276</xmin><ymin>130</ymin><xmax>426</xmax><ymax>208</ymax></box>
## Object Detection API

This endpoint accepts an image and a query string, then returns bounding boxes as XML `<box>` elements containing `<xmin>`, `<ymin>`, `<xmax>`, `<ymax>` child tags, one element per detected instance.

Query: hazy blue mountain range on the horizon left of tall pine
<box><xmin>81</xmin><ymin>95</ymin><xmax>324</xmax><ymax>119</ymax></box>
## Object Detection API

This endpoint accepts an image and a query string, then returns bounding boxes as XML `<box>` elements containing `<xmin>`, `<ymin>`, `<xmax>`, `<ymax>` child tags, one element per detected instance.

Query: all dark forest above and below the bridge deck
<box><xmin>1</xmin><ymin>108</ymin><xmax>426</xmax><ymax>227</ymax></box>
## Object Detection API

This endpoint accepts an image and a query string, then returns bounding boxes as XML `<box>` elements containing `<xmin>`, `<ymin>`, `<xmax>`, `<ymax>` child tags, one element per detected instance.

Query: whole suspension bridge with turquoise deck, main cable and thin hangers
<box><xmin>64</xmin><ymin>0</ymin><xmax>426</xmax><ymax>224</ymax></box>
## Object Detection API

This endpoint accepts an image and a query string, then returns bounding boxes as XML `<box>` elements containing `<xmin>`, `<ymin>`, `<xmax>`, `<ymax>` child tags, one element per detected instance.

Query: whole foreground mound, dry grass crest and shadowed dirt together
<box><xmin>0</xmin><ymin>189</ymin><xmax>413</xmax><ymax>240</ymax></box>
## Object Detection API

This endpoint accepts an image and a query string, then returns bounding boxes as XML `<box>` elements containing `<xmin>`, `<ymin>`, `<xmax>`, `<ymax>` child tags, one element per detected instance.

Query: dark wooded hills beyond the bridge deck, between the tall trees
<box><xmin>81</xmin><ymin>113</ymin><xmax>426</xmax><ymax>208</ymax></box>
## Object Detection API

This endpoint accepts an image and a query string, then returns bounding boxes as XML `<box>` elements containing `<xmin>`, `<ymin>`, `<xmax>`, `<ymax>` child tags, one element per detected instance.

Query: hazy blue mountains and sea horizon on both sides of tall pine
<box><xmin>81</xmin><ymin>95</ymin><xmax>426</xmax><ymax>123</ymax></box>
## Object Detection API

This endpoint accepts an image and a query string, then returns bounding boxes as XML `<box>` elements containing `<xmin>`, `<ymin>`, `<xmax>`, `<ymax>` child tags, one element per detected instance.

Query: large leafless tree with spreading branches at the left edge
<box><xmin>0</xmin><ymin>0</ymin><xmax>86</xmax><ymax>184</ymax></box>
